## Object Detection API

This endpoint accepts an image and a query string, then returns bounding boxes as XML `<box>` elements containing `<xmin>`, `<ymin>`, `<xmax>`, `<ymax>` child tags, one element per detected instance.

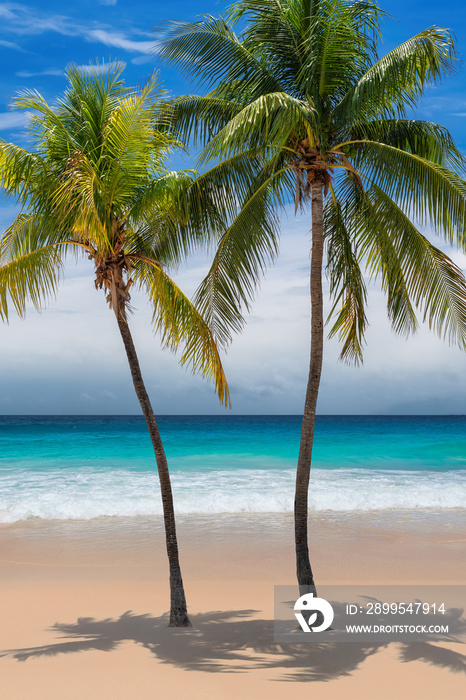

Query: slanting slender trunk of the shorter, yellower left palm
<box><xmin>115</xmin><ymin>303</ymin><xmax>191</xmax><ymax>627</ymax></box>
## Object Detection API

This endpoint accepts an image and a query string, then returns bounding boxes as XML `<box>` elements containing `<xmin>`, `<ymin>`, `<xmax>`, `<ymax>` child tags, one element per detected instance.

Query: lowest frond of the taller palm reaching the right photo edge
<box><xmin>336</xmin><ymin>178</ymin><xmax>466</xmax><ymax>347</ymax></box>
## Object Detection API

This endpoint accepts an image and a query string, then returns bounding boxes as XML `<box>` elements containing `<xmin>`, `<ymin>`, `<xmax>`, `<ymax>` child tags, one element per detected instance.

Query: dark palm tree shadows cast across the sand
<box><xmin>0</xmin><ymin>610</ymin><xmax>466</xmax><ymax>681</ymax></box>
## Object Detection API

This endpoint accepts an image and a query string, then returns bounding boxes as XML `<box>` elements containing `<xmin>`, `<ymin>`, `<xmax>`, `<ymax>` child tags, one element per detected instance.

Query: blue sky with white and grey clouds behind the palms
<box><xmin>0</xmin><ymin>0</ymin><xmax>466</xmax><ymax>414</ymax></box>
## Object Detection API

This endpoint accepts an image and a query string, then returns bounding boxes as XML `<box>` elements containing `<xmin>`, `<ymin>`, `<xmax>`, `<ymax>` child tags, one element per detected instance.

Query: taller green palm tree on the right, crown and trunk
<box><xmin>158</xmin><ymin>0</ymin><xmax>466</xmax><ymax>592</ymax></box>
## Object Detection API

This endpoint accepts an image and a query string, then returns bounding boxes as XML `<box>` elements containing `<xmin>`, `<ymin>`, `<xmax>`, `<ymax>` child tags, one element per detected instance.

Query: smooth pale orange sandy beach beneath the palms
<box><xmin>0</xmin><ymin>512</ymin><xmax>466</xmax><ymax>700</ymax></box>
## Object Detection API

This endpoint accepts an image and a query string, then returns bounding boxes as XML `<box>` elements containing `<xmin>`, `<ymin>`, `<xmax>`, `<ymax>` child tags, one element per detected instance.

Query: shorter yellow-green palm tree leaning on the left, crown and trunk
<box><xmin>0</xmin><ymin>64</ymin><xmax>229</xmax><ymax>627</ymax></box>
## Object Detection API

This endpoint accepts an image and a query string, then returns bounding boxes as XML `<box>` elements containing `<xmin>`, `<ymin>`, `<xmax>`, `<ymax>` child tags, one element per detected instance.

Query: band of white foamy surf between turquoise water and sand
<box><xmin>0</xmin><ymin>468</ymin><xmax>466</xmax><ymax>523</ymax></box>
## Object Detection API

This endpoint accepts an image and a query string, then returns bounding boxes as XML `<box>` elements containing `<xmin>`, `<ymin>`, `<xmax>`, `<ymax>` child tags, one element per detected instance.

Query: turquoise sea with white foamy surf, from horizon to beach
<box><xmin>0</xmin><ymin>416</ymin><xmax>466</xmax><ymax>523</ymax></box>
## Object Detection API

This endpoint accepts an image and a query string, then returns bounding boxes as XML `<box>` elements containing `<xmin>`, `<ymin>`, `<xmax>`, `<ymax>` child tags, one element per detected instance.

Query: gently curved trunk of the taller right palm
<box><xmin>294</xmin><ymin>180</ymin><xmax>324</xmax><ymax>595</ymax></box>
